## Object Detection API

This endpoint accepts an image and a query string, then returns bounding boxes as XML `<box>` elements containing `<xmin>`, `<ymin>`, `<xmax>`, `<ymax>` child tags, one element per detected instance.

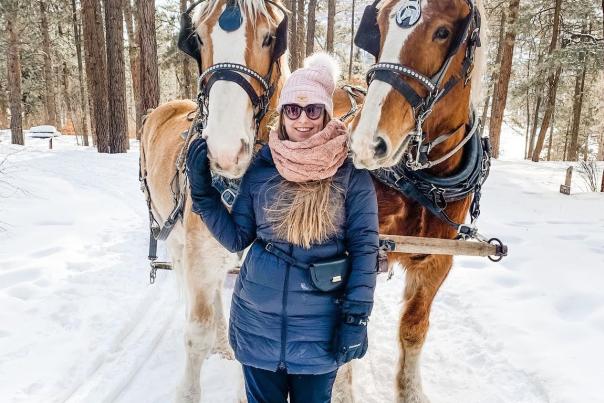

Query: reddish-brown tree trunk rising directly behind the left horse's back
<box><xmin>137</xmin><ymin>0</ymin><xmax>159</xmax><ymax>120</ymax></box>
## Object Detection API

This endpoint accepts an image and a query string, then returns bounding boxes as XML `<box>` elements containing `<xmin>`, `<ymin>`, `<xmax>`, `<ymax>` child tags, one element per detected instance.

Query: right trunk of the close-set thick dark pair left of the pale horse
<box><xmin>105</xmin><ymin>0</ymin><xmax>128</xmax><ymax>154</ymax></box>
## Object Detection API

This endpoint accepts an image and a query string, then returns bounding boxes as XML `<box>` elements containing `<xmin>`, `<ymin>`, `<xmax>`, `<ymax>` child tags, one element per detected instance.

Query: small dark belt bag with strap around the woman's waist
<box><xmin>259</xmin><ymin>241</ymin><xmax>350</xmax><ymax>292</ymax></box>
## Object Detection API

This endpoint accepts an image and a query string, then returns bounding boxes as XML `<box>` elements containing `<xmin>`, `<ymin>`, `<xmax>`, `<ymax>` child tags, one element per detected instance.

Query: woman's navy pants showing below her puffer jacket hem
<box><xmin>243</xmin><ymin>365</ymin><xmax>338</xmax><ymax>403</ymax></box>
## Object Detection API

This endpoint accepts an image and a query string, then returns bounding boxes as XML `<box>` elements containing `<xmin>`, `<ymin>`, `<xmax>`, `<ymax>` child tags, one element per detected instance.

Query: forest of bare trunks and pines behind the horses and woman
<box><xmin>0</xmin><ymin>0</ymin><xmax>604</xmax><ymax>186</ymax></box>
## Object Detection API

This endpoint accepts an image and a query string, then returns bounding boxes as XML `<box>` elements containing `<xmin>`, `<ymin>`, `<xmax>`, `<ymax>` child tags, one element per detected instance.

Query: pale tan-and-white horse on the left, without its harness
<box><xmin>140</xmin><ymin>0</ymin><xmax>363</xmax><ymax>402</ymax></box>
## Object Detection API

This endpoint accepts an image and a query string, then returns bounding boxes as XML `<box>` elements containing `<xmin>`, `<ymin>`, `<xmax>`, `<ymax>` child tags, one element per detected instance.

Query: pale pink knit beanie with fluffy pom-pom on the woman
<box><xmin>277</xmin><ymin>52</ymin><xmax>340</xmax><ymax>117</ymax></box>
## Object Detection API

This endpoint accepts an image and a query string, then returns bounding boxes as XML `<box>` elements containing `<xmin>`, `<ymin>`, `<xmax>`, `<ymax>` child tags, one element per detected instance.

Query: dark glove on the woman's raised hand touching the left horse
<box><xmin>187</xmin><ymin>137</ymin><xmax>213</xmax><ymax>200</ymax></box>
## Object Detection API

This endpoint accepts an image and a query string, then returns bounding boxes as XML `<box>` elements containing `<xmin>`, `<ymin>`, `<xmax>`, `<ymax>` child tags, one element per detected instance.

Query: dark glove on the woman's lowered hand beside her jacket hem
<box><xmin>334</xmin><ymin>314</ymin><xmax>369</xmax><ymax>366</ymax></box>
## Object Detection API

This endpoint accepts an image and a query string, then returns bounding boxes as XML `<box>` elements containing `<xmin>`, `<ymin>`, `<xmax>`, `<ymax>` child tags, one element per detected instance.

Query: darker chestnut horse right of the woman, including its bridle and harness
<box><xmin>351</xmin><ymin>0</ymin><xmax>490</xmax><ymax>403</ymax></box>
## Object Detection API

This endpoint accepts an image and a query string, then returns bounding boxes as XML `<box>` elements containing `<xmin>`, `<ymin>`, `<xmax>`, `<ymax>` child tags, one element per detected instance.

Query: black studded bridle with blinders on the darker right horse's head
<box><xmin>354</xmin><ymin>0</ymin><xmax>481</xmax><ymax>170</ymax></box>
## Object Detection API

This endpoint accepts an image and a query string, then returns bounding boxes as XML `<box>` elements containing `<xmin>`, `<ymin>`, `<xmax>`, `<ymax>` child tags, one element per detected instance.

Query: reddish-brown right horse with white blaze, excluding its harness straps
<box><xmin>351</xmin><ymin>0</ymin><xmax>485</xmax><ymax>402</ymax></box>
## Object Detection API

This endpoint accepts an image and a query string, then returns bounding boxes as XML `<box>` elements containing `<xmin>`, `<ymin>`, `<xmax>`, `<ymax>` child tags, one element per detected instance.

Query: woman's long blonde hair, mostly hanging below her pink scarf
<box><xmin>265</xmin><ymin>113</ymin><xmax>344</xmax><ymax>249</ymax></box>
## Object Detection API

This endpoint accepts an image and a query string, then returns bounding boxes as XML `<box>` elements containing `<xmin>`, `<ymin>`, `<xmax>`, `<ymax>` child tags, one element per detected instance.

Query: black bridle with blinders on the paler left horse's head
<box><xmin>178</xmin><ymin>0</ymin><xmax>288</xmax><ymax>130</ymax></box>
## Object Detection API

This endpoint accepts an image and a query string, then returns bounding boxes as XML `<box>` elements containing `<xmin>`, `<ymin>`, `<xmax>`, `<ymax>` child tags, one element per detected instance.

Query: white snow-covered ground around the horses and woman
<box><xmin>0</xmin><ymin>130</ymin><xmax>604</xmax><ymax>403</ymax></box>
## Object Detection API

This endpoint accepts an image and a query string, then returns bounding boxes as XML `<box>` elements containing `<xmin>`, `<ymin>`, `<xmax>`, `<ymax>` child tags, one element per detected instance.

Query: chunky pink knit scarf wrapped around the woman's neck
<box><xmin>268</xmin><ymin>120</ymin><xmax>348</xmax><ymax>182</ymax></box>
